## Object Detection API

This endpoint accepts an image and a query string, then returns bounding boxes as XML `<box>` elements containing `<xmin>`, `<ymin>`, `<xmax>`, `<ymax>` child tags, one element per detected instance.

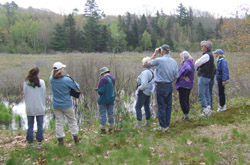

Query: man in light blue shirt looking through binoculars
<box><xmin>146</xmin><ymin>44</ymin><xmax>178</xmax><ymax>131</ymax></box>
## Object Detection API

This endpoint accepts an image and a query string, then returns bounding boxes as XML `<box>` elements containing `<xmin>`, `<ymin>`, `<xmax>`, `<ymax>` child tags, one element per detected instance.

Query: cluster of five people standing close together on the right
<box><xmin>135</xmin><ymin>41</ymin><xmax>229</xmax><ymax>131</ymax></box>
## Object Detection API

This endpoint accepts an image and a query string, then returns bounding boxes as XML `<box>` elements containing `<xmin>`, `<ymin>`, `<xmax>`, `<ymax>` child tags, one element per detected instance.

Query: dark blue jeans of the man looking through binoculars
<box><xmin>156</xmin><ymin>83</ymin><xmax>173</xmax><ymax>128</ymax></box>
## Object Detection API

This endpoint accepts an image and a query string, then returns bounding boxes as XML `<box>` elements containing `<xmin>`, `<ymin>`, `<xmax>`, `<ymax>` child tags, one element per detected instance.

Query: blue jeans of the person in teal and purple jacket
<box><xmin>99</xmin><ymin>102</ymin><xmax>114</xmax><ymax>125</ymax></box>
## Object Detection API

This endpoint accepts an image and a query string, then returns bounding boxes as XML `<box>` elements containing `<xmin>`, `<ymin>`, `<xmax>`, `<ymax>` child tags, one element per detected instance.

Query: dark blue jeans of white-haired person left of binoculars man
<box><xmin>135</xmin><ymin>92</ymin><xmax>151</xmax><ymax>121</ymax></box>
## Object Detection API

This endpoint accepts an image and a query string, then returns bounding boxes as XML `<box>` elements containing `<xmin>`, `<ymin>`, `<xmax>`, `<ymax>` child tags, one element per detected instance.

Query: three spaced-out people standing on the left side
<box><xmin>23</xmin><ymin>62</ymin><xmax>115</xmax><ymax>149</ymax></box>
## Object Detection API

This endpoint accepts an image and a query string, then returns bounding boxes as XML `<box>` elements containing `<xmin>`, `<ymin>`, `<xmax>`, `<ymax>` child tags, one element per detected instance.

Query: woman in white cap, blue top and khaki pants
<box><xmin>49</xmin><ymin>62</ymin><xmax>80</xmax><ymax>145</ymax></box>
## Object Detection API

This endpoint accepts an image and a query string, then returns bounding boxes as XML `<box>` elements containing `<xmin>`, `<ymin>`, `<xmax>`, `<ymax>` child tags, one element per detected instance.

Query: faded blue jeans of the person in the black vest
<box><xmin>198</xmin><ymin>76</ymin><xmax>211</xmax><ymax>108</ymax></box>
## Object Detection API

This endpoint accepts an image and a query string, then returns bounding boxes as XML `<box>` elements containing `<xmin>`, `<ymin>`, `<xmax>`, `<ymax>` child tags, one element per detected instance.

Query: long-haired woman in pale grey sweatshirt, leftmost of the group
<box><xmin>23</xmin><ymin>67</ymin><xmax>46</xmax><ymax>149</ymax></box>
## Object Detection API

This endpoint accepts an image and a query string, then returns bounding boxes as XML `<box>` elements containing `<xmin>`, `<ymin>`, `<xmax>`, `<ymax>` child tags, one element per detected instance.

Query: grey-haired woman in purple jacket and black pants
<box><xmin>175</xmin><ymin>51</ymin><xmax>195</xmax><ymax>121</ymax></box>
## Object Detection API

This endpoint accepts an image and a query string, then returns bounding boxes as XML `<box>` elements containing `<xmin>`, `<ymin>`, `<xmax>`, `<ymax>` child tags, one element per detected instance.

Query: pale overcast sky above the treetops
<box><xmin>0</xmin><ymin>0</ymin><xmax>250</xmax><ymax>17</ymax></box>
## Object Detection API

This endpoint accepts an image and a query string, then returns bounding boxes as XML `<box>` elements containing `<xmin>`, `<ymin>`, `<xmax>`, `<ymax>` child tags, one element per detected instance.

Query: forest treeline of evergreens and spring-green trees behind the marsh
<box><xmin>0</xmin><ymin>0</ymin><xmax>250</xmax><ymax>53</ymax></box>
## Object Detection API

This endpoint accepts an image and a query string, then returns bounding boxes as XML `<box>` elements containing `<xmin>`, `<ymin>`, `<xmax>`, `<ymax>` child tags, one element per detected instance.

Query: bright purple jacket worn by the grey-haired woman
<box><xmin>175</xmin><ymin>59</ymin><xmax>195</xmax><ymax>90</ymax></box>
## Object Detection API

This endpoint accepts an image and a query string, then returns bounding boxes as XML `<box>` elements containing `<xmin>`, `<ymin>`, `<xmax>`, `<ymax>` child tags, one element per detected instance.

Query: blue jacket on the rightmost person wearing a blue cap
<box><xmin>216</xmin><ymin>57</ymin><xmax>229</xmax><ymax>81</ymax></box>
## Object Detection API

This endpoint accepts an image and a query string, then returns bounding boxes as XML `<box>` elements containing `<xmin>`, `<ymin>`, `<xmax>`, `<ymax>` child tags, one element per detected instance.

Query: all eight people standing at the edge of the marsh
<box><xmin>23</xmin><ymin>41</ymin><xmax>229</xmax><ymax>149</ymax></box>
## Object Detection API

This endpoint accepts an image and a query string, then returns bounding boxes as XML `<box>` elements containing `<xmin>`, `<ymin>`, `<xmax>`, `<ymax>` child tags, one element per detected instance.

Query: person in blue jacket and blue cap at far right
<box><xmin>213</xmin><ymin>49</ymin><xmax>229</xmax><ymax>112</ymax></box>
